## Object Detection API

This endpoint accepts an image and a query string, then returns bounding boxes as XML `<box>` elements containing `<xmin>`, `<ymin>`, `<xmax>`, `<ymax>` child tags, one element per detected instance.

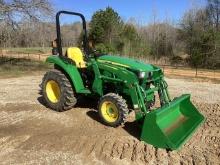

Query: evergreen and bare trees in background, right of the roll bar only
<box><xmin>89</xmin><ymin>3</ymin><xmax>220</xmax><ymax>67</ymax></box>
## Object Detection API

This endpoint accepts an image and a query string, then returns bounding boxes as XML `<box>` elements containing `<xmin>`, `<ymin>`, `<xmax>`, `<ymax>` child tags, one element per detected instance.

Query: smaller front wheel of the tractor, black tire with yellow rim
<box><xmin>98</xmin><ymin>93</ymin><xmax>129</xmax><ymax>127</ymax></box>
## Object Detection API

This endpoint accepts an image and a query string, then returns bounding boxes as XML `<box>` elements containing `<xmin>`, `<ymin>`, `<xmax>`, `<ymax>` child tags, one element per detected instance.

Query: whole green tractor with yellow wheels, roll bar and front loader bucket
<box><xmin>41</xmin><ymin>11</ymin><xmax>205</xmax><ymax>150</ymax></box>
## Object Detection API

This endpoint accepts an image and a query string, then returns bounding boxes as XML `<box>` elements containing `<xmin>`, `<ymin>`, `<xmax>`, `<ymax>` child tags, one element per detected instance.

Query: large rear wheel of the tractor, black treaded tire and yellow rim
<box><xmin>41</xmin><ymin>70</ymin><xmax>77</xmax><ymax>112</ymax></box>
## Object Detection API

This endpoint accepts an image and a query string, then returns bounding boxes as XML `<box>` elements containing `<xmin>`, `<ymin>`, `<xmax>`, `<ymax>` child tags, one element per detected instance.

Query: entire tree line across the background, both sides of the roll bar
<box><xmin>0</xmin><ymin>0</ymin><xmax>220</xmax><ymax>68</ymax></box>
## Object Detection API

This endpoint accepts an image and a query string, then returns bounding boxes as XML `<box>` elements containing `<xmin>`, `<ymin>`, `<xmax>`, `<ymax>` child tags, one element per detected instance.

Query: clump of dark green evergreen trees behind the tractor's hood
<box><xmin>89</xmin><ymin>7</ymin><xmax>149</xmax><ymax>56</ymax></box>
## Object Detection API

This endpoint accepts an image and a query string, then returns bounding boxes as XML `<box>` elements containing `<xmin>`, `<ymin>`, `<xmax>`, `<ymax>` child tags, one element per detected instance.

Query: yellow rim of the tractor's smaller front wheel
<box><xmin>101</xmin><ymin>101</ymin><xmax>119</xmax><ymax>122</ymax></box>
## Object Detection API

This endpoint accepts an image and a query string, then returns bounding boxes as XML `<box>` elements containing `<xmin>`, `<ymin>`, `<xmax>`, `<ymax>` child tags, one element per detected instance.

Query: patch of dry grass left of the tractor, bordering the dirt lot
<box><xmin>0</xmin><ymin>57</ymin><xmax>53</xmax><ymax>78</ymax></box>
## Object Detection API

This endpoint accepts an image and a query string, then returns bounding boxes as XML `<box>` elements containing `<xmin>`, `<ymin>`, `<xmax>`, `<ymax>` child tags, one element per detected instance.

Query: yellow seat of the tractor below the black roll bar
<box><xmin>67</xmin><ymin>47</ymin><xmax>86</xmax><ymax>68</ymax></box>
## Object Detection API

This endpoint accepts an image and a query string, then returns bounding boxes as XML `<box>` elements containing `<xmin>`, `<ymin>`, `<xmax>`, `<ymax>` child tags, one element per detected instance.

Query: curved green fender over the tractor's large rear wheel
<box><xmin>46</xmin><ymin>56</ymin><xmax>91</xmax><ymax>94</ymax></box>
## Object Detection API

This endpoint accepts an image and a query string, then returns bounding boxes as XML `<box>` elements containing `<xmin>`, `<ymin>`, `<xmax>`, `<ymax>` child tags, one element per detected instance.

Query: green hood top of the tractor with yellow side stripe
<box><xmin>97</xmin><ymin>55</ymin><xmax>159</xmax><ymax>71</ymax></box>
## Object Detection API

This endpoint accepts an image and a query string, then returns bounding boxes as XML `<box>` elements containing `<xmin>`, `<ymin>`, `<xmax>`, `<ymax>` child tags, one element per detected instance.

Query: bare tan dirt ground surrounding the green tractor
<box><xmin>0</xmin><ymin>75</ymin><xmax>220</xmax><ymax>165</ymax></box>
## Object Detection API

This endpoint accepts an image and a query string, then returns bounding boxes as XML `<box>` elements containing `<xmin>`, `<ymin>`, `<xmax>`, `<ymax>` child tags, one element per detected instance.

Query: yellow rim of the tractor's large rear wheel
<box><xmin>46</xmin><ymin>80</ymin><xmax>60</xmax><ymax>103</ymax></box>
